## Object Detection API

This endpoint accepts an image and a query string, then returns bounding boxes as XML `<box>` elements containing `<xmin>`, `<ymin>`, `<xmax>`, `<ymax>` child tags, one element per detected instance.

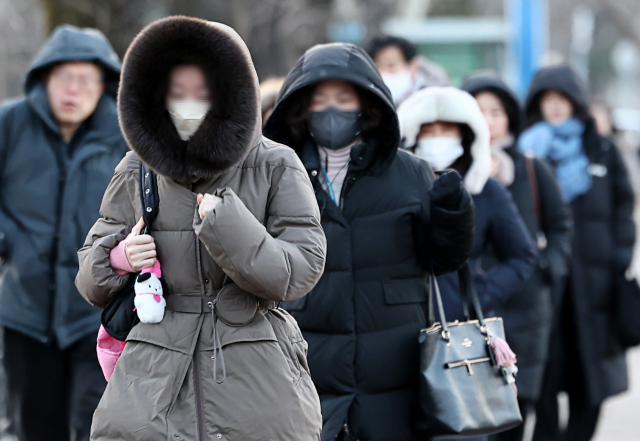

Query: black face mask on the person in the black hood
<box><xmin>309</xmin><ymin>107</ymin><xmax>361</xmax><ymax>150</ymax></box>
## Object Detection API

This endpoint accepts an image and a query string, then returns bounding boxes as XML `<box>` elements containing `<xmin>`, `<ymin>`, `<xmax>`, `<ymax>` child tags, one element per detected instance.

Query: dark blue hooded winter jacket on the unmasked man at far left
<box><xmin>0</xmin><ymin>26</ymin><xmax>127</xmax><ymax>348</ymax></box>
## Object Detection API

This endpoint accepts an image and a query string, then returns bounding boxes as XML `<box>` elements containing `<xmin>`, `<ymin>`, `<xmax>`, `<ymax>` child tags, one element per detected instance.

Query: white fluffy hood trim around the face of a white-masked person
<box><xmin>398</xmin><ymin>87</ymin><xmax>491</xmax><ymax>194</ymax></box>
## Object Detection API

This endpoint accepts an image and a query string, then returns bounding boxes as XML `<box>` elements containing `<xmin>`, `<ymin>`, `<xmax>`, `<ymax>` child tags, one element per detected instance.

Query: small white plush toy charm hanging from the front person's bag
<box><xmin>134</xmin><ymin>261</ymin><xmax>167</xmax><ymax>323</ymax></box>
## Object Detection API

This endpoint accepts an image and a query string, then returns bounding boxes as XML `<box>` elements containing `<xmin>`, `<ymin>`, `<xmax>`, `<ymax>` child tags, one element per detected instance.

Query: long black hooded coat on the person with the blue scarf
<box><xmin>525</xmin><ymin>66</ymin><xmax>635</xmax><ymax>405</ymax></box>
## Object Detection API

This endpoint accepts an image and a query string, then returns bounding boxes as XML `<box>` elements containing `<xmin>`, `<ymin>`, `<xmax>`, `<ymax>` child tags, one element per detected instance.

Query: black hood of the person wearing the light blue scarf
<box><xmin>524</xmin><ymin>66</ymin><xmax>591</xmax><ymax>127</ymax></box>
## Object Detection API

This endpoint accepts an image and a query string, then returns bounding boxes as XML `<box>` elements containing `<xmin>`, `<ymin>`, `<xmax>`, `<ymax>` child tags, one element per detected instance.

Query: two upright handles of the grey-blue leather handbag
<box><xmin>428</xmin><ymin>263</ymin><xmax>487</xmax><ymax>341</ymax></box>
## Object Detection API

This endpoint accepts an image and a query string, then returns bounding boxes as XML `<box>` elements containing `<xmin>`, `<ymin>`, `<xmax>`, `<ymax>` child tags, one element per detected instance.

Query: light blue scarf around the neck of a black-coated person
<box><xmin>518</xmin><ymin>117</ymin><xmax>593</xmax><ymax>202</ymax></box>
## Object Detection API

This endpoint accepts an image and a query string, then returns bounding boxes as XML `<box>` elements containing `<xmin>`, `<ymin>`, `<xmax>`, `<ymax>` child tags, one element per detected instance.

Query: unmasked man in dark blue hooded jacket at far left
<box><xmin>0</xmin><ymin>26</ymin><xmax>127</xmax><ymax>441</ymax></box>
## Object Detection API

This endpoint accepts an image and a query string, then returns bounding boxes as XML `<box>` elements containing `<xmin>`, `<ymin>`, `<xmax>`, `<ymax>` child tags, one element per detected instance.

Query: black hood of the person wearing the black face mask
<box><xmin>264</xmin><ymin>43</ymin><xmax>400</xmax><ymax>172</ymax></box>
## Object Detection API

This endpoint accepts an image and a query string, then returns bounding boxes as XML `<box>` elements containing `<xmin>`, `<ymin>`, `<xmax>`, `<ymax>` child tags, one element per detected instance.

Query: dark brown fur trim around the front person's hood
<box><xmin>118</xmin><ymin>16</ymin><xmax>262</xmax><ymax>183</ymax></box>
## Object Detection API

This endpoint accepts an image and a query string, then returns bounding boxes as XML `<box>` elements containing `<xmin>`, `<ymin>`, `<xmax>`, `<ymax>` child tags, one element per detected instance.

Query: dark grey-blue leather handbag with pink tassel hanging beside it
<box><xmin>417</xmin><ymin>265</ymin><xmax>522</xmax><ymax>439</ymax></box>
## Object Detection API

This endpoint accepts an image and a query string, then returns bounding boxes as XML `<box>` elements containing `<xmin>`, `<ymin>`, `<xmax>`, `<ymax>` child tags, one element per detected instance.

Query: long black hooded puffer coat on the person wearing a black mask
<box><xmin>265</xmin><ymin>44</ymin><xmax>473</xmax><ymax>441</ymax></box>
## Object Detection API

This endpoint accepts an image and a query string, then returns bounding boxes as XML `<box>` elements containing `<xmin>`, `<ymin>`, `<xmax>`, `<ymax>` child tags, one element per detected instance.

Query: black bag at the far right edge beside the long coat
<box><xmin>615</xmin><ymin>276</ymin><xmax>640</xmax><ymax>349</ymax></box>
